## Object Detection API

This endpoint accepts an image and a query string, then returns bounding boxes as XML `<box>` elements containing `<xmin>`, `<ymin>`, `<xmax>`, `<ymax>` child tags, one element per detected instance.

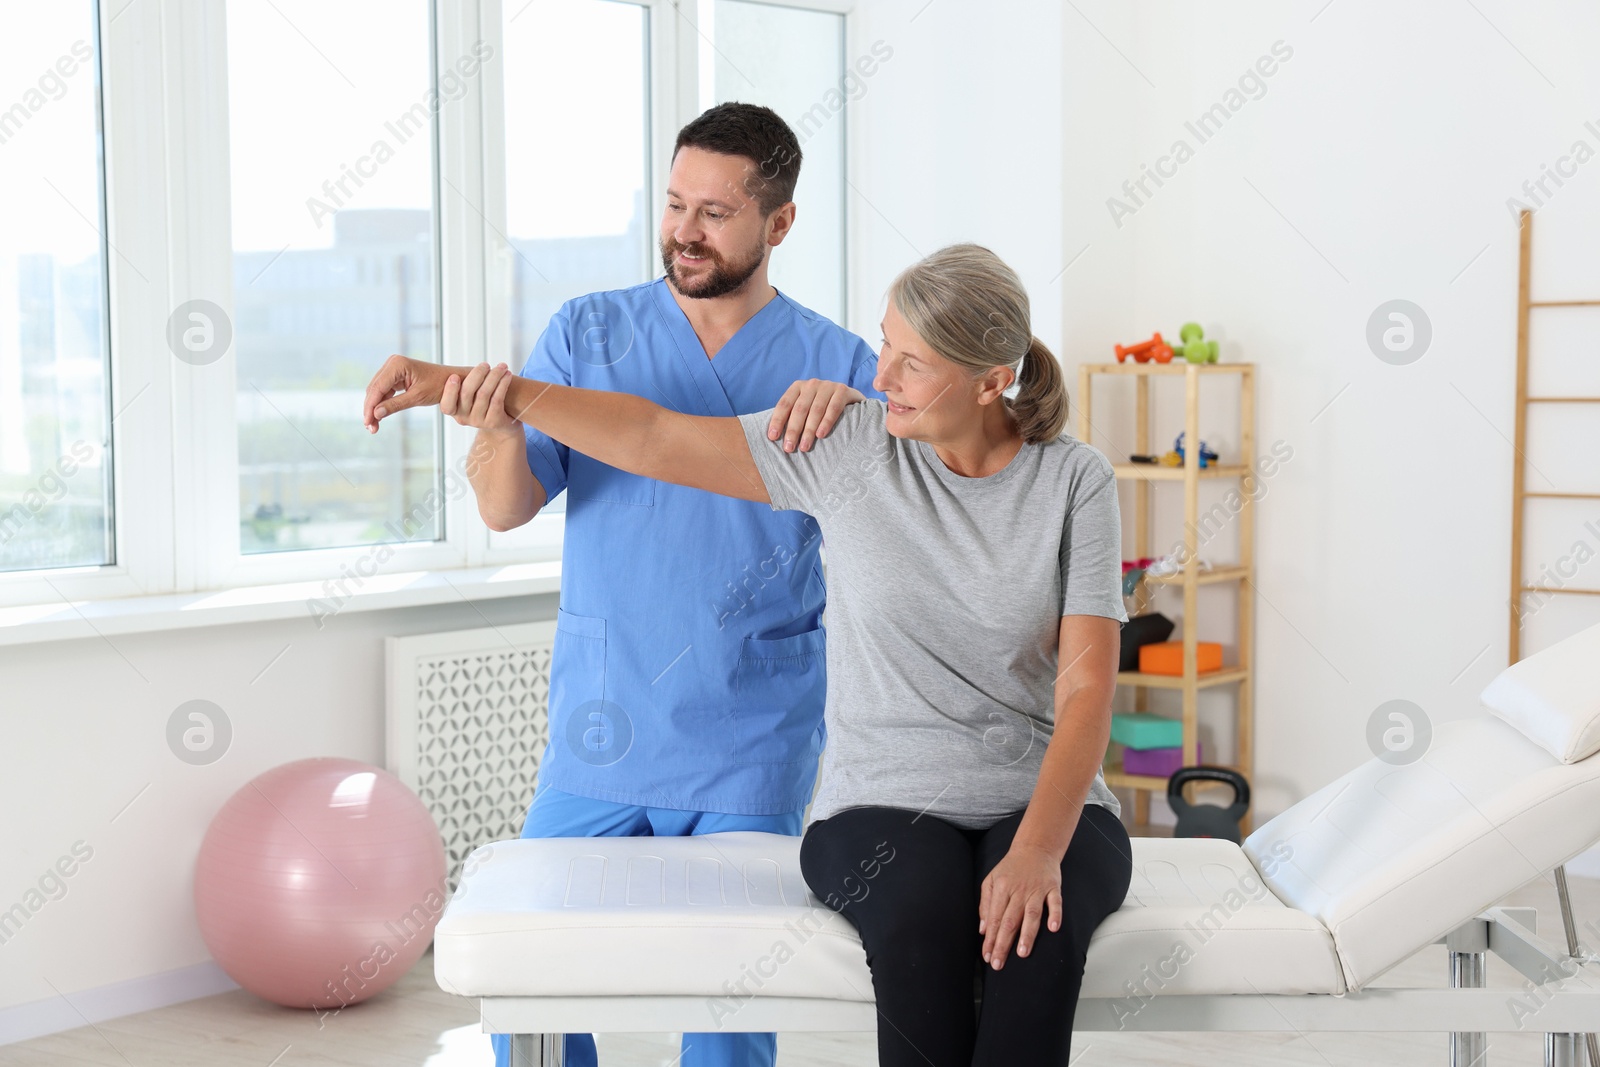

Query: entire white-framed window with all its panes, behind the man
<box><xmin>0</xmin><ymin>0</ymin><xmax>845</xmax><ymax>613</ymax></box>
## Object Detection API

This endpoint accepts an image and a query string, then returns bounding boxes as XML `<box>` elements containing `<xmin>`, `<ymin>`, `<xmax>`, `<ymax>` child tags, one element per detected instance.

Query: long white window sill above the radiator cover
<box><xmin>0</xmin><ymin>560</ymin><xmax>562</xmax><ymax>646</ymax></box>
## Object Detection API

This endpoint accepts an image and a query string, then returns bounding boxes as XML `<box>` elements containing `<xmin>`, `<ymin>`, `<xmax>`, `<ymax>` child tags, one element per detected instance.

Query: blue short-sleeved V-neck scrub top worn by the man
<box><xmin>522</xmin><ymin>278</ymin><xmax>882</xmax><ymax>814</ymax></box>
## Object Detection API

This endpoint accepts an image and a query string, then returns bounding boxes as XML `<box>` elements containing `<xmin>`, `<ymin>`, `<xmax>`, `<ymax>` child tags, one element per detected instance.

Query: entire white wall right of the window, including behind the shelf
<box><xmin>851</xmin><ymin>0</ymin><xmax>1600</xmax><ymax>816</ymax></box>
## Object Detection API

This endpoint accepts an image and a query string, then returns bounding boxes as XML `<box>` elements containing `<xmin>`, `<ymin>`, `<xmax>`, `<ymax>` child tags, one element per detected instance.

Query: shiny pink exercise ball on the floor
<box><xmin>195</xmin><ymin>758</ymin><xmax>450</xmax><ymax>1008</ymax></box>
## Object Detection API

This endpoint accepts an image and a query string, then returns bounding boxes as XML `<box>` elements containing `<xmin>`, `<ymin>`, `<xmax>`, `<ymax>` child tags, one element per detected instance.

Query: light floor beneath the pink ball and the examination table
<box><xmin>0</xmin><ymin>878</ymin><xmax>1600</xmax><ymax>1067</ymax></box>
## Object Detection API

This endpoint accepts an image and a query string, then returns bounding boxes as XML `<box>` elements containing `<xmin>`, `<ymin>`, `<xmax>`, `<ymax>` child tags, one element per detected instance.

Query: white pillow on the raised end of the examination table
<box><xmin>1478</xmin><ymin>625</ymin><xmax>1600</xmax><ymax>763</ymax></box>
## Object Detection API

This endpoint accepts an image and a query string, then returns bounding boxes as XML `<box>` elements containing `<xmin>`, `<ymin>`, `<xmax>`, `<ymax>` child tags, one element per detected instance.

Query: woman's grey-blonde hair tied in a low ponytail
<box><xmin>890</xmin><ymin>245</ymin><xmax>1067</xmax><ymax>445</ymax></box>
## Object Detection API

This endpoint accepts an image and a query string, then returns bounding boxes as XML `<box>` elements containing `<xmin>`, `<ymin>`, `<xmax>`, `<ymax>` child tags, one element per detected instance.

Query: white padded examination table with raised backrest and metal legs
<box><xmin>434</xmin><ymin>627</ymin><xmax>1600</xmax><ymax>1067</ymax></box>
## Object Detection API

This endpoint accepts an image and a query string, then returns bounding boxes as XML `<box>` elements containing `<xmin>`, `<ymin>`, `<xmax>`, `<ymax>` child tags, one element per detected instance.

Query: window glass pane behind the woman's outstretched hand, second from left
<box><xmin>222</xmin><ymin>0</ymin><xmax>441</xmax><ymax>555</ymax></box>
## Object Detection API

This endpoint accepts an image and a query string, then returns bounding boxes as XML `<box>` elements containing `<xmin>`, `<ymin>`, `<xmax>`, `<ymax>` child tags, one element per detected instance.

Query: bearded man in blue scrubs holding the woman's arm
<box><xmin>457</xmin><ymin>104</ymin><xmax>882</xmax><ymax>1067</ymax></box>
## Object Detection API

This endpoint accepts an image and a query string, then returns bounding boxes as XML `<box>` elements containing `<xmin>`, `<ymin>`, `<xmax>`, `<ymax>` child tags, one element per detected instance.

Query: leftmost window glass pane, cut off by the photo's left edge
<box><xmin>0</xmin><ymin>3</ymin><xmax>115</xmax><ymax>571</ymax></box>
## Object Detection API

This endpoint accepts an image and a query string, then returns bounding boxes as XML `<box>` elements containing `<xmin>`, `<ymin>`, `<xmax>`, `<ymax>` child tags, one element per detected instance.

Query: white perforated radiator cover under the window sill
<box><xmin>384</xmin><ymin>622</ymin><xmax>555</xmax><ymax>893</ymax></box>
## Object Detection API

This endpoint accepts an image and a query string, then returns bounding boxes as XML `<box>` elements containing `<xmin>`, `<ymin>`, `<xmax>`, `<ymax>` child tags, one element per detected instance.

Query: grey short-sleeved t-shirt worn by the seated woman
<box><xmin>739</xmin><ymin>400</ymin><xmax>1128</xmax><ymax>829</ymax></box>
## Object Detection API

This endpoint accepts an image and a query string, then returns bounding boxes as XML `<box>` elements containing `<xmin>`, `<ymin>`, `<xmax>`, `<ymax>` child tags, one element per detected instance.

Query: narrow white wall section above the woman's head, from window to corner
<box><xmin>846</xmin><ymin>0</ymin><xmax>1066</xmax><ymax>355</ymax></box>
